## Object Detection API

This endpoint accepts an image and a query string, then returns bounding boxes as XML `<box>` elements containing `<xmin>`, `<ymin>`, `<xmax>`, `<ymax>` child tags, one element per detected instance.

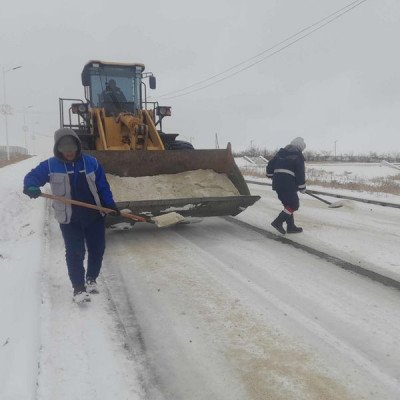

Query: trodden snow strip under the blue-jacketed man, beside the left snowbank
<box><xmin>37</xmin><ymin>208</ymin><xmax>143</xmax><ymax>400</ymax></box>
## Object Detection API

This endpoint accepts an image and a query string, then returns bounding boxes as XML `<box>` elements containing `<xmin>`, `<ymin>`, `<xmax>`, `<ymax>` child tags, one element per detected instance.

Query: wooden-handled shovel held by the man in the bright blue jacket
<box><xmin>41</xmin><ymin>193</ymin><xmax>185</xmax><ymax>228</ymax></box>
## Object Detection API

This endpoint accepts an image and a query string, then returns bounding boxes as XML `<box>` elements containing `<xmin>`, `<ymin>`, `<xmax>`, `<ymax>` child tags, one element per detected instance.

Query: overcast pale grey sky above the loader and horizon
<box><xmin>0</xmin><ymin>0</ymin><xmax>400</xmax><ymax>153</ymax></box>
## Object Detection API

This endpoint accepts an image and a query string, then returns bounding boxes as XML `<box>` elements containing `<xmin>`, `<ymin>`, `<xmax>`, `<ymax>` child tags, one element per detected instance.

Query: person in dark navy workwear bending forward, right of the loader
<box><xmin>267</xmin><ymin>137</ymin><xmax>306</xmax><ymax>234</ymax></box>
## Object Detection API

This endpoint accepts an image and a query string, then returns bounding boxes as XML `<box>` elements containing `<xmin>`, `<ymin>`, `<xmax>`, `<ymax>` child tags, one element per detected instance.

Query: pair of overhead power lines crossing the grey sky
<box><xmin>158</xmin><ymin>0</ymin><xmax>367</xmax><ymax>99</ymax></box>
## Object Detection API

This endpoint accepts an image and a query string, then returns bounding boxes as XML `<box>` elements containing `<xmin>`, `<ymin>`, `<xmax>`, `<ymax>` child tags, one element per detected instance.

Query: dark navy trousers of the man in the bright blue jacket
<box><xmin>60</xmin><ymin>217</ymin><xmax>105</xmax><ymax>289</ymax></box>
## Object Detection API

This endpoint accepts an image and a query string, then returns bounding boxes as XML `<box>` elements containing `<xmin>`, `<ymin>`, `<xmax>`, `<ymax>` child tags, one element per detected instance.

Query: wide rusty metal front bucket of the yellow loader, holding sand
<box><xmin>87</xmin><ymin>145</ymin><xmax>260</xmax><ymax>221</ymax></box>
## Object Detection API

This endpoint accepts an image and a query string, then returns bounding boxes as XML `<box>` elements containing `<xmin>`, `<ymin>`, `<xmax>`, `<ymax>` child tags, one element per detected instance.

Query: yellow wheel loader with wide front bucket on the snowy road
<box><xmin>59</xmin><ymin>61</ymin><xmax>259</xmax><ymax>224</ymax></box>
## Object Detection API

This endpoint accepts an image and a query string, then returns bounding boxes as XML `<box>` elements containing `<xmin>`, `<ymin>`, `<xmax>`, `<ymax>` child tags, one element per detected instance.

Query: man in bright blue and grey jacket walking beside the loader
<box><xmin>24</xmin><ymin>128</ymin><xmax>120</xmax><ymax>302</ymax></box>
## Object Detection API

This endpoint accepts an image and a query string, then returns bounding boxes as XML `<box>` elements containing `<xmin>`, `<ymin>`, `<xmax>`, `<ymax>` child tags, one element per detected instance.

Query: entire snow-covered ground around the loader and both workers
<box><xmin>0</xmin><ymin>159</ymin><xmax>400</xmax><ymax>400</ymax></box>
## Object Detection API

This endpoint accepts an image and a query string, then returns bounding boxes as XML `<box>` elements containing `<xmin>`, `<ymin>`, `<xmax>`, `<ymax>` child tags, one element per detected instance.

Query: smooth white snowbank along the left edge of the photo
<box><xmin>0</xmin><ymin>157</ymin><xmax>45</xmax><ymax>400</ymax></box>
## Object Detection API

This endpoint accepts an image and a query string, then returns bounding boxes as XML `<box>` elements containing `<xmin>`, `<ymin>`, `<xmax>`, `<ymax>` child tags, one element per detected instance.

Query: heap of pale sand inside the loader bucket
<box><xmin>107</xmin><ymin>169</ymin><xmax>240</xmax><ymax>202</ymax></box>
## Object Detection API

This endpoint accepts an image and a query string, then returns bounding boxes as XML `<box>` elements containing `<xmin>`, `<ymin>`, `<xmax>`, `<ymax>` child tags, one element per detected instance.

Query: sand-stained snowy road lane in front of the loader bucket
<box><xmin>104</xmin><ymin>218</ymin><xmax>400</xmax><ymax>399</ymax></box>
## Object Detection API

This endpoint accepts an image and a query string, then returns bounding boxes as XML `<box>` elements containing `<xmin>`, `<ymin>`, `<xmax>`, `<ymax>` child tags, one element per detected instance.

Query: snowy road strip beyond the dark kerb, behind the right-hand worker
<box><xmin>241</xmin><ymin>185</ymin><xmax>400</xmax><ymax>281</ymax></box>
